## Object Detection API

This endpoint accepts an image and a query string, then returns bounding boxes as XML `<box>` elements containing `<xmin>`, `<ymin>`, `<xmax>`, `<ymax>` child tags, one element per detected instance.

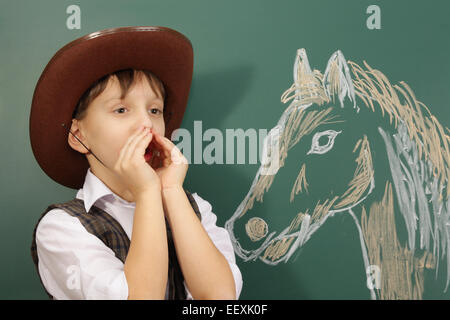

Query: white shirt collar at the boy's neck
<box><xmin>76</xmin><ymin>168</ymin><xmax>135</xmax><ymax>212</ymax></box>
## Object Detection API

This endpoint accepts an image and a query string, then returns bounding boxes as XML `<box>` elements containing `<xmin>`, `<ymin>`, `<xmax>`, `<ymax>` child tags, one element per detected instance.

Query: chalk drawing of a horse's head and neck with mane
<box><xmin>225</xmin><ymin>49</ymin><xmax>450</xmax><ymax>299</ymax></box>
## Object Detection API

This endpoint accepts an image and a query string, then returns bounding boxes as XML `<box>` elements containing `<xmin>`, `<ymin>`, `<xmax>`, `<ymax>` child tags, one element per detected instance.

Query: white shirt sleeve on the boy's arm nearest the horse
<box><xmin>185</xmin><ymin>193</ymin><xmax>243</xmax><ymax>300</ymax></box>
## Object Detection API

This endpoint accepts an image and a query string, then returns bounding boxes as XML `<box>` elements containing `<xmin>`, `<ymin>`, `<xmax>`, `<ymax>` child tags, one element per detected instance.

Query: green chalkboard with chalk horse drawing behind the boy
<box><xmin>0</xmin><ymin>0</ymin><xmax>450</xmax><ymax>299</ymax></box>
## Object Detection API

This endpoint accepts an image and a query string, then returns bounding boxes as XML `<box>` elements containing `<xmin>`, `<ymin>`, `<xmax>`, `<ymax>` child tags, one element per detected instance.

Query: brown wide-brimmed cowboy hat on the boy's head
<box><xmin>30</xmin><ymin>26</ymin><xmax>193</xmax><ymax>189</ymax></box>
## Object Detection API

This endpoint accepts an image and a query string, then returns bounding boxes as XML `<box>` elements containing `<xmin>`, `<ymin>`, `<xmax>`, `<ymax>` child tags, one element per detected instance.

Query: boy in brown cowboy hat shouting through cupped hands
<box><xmin>30</xmin><ymin>27</ymin><xmax>242</xmax><ymax>299</ymax></box>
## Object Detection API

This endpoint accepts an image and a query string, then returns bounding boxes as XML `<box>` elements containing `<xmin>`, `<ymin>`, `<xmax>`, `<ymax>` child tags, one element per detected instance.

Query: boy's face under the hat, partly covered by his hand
<box><xmin>69</xmin><ymin>77</ymin><xmax>165</xmax><ymax>169</ymax></box>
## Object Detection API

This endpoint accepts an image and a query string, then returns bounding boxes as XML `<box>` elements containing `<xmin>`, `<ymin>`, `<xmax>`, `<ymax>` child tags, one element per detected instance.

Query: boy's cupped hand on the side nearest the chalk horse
<box><xmin>152</xmin><ymin>129</ymin><xmax>188</xmax><ymax>190</ymax></box>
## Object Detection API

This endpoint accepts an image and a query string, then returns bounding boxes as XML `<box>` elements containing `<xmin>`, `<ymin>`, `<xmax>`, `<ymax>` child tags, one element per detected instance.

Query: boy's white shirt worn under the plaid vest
<box><xmin>36</xmin><ymin>169</ymin><xmax>242</xmax><ymax>300</ymax></box>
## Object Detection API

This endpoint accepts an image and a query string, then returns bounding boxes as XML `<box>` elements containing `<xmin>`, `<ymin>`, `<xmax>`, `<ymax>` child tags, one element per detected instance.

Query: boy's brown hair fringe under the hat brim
<box><xmin>72</xmin><ymin>69</ymin><xmax>170</xmax><ymax>123</ymax></box>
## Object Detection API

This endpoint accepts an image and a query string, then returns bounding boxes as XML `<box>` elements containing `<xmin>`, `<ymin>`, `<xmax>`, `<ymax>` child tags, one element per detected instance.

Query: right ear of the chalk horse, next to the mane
<box><xmin>323</xmin><ymin>50</ymin><xmax>357</xmax><ymax>108</ymax></box>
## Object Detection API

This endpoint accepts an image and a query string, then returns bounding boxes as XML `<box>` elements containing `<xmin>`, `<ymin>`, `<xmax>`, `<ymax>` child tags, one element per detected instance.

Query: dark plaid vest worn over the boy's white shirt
<box><xmin>31</xmin><ymin>190</ymin><xmax>201</xmax><ymax>300</ymax></box>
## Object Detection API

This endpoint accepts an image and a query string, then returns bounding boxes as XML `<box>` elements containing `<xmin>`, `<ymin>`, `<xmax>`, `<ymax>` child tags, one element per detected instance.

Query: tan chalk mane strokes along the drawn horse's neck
<box><xmin>349</xmin><ymin>61</ymin><xmax>450</xmax><ymax>200</ymax></box>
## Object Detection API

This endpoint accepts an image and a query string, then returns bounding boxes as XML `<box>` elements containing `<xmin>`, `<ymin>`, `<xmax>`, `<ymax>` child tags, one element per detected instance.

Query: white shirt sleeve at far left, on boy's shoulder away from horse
<box><xmin>36</xmin><ymin>209</ymin><xmax>128</xmax><ymax>300</ymax></box>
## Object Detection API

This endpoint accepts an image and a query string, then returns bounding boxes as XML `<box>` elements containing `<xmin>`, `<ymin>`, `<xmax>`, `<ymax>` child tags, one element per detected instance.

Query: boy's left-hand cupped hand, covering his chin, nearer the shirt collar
<box><xmin>113</xmin><ymin>127</ymin><xmax>160</xmax><ymax>199</ymax></box>
